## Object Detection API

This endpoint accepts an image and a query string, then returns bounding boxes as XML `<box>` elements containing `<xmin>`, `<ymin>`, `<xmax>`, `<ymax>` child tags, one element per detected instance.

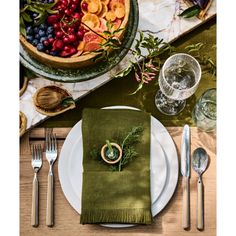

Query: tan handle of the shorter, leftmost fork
<box><xmin>31</xmin><ymin>173</ymin><xmax>39</xmax><ymax>227</ymax></box>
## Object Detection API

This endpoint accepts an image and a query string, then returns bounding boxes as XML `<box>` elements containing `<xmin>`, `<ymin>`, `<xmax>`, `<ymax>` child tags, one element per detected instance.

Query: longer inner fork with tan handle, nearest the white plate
<box><xmin>46</xmin><ymin>132</ymin><xmax>57</xmax><ymax>226</ymax></box>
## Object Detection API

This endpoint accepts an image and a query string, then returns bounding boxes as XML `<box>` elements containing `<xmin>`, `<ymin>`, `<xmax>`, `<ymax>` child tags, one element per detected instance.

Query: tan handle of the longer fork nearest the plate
<box><xmin>46</xmin><ymin>171</ymin><xmax>54</xmax><ymax>226</ymax></box>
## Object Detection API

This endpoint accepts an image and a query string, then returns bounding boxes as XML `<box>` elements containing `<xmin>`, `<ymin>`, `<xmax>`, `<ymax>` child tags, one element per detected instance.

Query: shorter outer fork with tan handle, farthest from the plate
<box><xmin>31</xmin><ymin>145</ymin><xmax>42</xmax><ymax>227</ymax></box>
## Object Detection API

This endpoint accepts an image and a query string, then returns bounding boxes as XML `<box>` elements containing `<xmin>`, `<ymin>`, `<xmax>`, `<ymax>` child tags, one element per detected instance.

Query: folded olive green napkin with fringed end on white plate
<box><xmin>80</xmin><ymin>109</ymin><xmax>152</xmax><ymax>224</ymax></box>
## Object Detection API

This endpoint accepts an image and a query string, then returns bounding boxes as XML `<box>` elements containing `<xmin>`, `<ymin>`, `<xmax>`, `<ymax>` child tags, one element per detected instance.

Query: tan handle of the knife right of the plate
<box><xmin>182</xmin><ymin>176</ymin><xmax>190</xmax><ymax>229</ymax></box>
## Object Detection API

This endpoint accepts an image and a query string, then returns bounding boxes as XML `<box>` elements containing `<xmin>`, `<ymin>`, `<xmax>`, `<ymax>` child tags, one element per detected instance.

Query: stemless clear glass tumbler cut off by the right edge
<box><xmin>192</xmin><ymin>88</ymin><xmax>216</xmax><ymax>132</ymax></box>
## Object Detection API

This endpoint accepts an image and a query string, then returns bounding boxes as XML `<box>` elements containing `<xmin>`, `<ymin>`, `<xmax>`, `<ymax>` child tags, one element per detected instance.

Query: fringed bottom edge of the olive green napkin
<box><xmin>80</xmin><ymin>208</ymin><xmax>152</xmax><ymax>224</ymax></box>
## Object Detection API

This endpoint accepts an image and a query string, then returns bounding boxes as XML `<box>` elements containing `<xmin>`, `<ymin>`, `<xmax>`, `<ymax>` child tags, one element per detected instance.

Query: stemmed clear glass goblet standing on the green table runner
<box><xmin>155</xmin><ymin>53</ymin><xmax>201</xmax><ymax>115</ymax></box>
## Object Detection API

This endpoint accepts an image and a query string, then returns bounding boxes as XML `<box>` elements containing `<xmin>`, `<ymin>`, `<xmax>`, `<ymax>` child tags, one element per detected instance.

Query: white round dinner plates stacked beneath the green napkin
<box><xmin>58</xmin><ymin>106</ymin><xmax>178</xmax><ymax>228</ymax></box>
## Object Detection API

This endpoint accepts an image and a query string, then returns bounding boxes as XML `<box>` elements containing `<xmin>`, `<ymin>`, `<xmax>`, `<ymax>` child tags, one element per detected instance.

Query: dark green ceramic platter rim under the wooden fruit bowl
<box><xmin>20</xmin><ymin>0</ymin><xmax>139</xmax><ymax>83</ymax></box>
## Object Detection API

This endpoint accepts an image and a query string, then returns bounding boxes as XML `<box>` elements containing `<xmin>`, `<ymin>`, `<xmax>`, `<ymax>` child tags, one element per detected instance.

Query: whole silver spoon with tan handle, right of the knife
<box><xmin>192</xmin><ymin>148</ymin><xmax>208</xmax><ymax>230</ymax></box>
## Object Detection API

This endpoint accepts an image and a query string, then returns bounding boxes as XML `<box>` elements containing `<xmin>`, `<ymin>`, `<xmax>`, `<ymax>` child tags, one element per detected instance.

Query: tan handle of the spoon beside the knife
<box><xmin>197</xmin><ymin>178</ymin><xmax>204</xmax><ymax>230</ymax></box>
